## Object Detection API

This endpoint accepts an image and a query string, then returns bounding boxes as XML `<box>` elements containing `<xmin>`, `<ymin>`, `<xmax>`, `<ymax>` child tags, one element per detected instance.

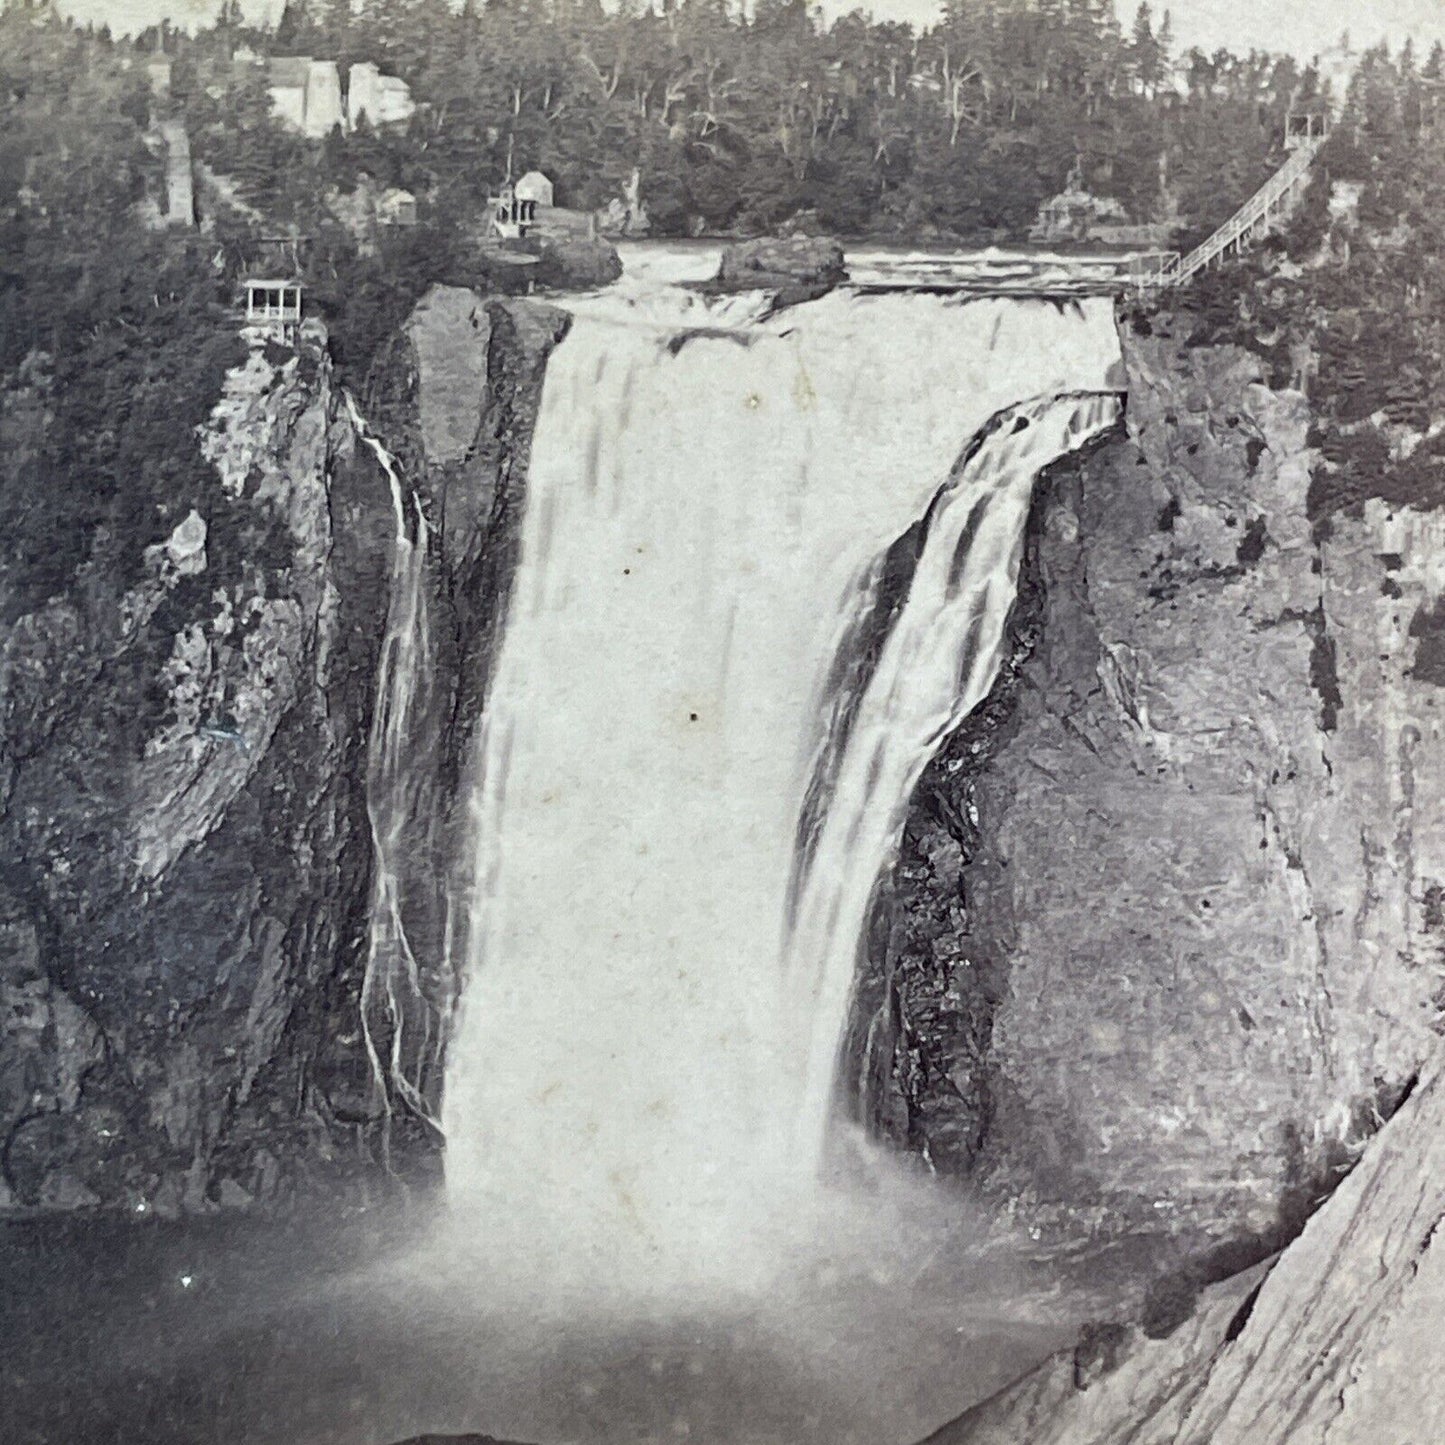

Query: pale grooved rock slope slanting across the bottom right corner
<box><xmin>929</xmin><ymin>1057</ymin><xmax>1445</xmax><ymax>1445</ymax></box>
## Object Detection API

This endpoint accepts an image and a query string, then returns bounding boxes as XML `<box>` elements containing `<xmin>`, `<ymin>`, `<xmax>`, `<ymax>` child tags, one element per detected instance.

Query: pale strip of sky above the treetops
<box><xmin>45</xmin><ymin>0</ymin><xmax>1445</xmax><ymax>58</ymax></box>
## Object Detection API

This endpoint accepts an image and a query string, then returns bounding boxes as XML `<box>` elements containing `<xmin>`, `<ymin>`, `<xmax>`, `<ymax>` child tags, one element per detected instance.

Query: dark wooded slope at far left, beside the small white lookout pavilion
<box><xmin>0</xmin><ymin>10</ymin><xmax>244</xmax><ymax>616</ymax></box>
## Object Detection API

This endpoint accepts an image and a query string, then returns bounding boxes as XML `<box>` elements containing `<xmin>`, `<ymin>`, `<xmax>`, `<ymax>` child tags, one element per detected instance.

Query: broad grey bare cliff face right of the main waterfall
<box><xmin>857</xmin><ymin>316</ymin><xmax>1445</xmax><ymax>1241</ymax></box>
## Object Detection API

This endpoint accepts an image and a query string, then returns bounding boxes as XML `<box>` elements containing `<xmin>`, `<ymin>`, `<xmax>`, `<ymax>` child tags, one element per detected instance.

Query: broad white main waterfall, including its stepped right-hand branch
<box><xmin>442</xmin><ymin>275</ymin><xmax>1118</xmax><ymax>1292</ymax></box>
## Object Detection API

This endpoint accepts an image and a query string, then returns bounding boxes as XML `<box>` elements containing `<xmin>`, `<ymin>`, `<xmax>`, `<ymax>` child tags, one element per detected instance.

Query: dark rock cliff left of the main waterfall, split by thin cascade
<box><xmin>0</xmin><ymin>281</ymin><xmax>565</xmax><ymax>1212</ymax></box>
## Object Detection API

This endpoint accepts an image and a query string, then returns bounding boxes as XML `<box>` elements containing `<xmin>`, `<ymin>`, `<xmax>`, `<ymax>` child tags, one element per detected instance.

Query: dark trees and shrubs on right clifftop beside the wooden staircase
<box><xmin>1156</xmin><ymin>49</ymin><xmax>1445</xmax><ymax>543</ymax></box>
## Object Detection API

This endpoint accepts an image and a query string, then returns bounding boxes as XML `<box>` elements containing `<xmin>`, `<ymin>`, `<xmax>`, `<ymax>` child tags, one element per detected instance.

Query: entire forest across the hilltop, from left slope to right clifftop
<box><xmin>0</xmin><ymin>0</ymin><xmax>1445</xmax><ymax>614</ymax></box>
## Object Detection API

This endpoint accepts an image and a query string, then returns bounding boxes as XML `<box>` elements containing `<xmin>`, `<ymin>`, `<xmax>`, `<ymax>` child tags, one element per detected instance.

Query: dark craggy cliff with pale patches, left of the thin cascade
<box><xmin>0</xmin><ymin>332</ymin><xmax>390</xmax><ymax>1212</ymax></box>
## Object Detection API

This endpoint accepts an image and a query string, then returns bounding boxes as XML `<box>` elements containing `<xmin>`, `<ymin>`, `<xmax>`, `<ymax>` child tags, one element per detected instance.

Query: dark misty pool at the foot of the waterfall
<box><xmin>0</xmin><ymin>1208</ymin><xmax>1079</xmax><ymax>1445</ymax></box>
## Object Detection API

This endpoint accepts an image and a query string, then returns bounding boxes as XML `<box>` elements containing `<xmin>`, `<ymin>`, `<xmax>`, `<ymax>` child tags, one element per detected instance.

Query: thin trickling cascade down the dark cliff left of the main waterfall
<box><xmin>344</xmin><ymin>393</ymin><xmax>441</xmax><ymax>1123</ymax></box>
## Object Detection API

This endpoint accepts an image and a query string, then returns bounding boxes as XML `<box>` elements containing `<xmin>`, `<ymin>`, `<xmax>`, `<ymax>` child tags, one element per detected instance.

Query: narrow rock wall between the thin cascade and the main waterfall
<box><xmin>352</xmin><ymin>286</ymin><xmax>566</xmax><ymax>1127</ymax></box>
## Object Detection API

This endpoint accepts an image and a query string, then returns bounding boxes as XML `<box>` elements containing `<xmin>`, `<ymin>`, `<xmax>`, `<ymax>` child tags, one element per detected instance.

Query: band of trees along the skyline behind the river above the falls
<box><xmin>8</xmin><ymin>0</ymin><xmax>1315</xmax><ymax>240</ymax></box>
